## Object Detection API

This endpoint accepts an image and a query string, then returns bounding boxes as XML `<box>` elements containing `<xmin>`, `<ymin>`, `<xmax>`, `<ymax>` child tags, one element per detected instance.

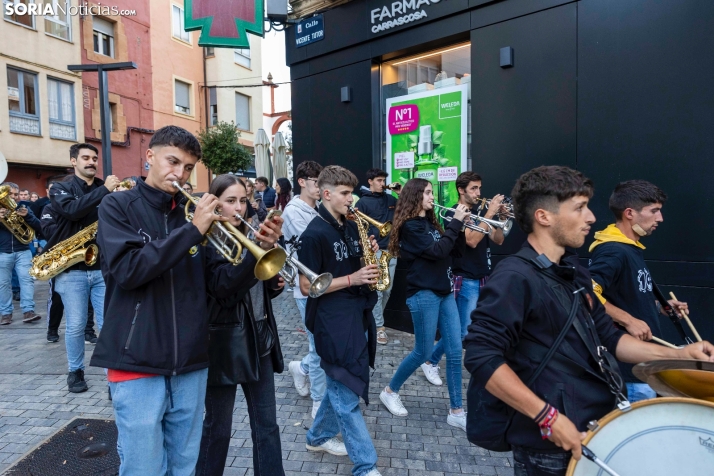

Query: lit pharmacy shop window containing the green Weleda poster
<box><xmin>380</xmin><ymin>43</ymin><xmax>472</xmax><ymax>206</ymax></box>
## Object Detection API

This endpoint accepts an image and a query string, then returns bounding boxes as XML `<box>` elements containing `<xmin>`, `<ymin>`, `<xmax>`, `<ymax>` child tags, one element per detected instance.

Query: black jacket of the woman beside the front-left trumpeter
<box><xmin>206</xmin><ymin>249</ymin><xmax>284</xmax><ymax>386</ymax></box>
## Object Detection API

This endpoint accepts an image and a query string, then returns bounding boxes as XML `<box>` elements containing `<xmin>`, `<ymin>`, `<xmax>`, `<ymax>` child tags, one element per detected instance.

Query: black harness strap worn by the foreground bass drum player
<box><xmin>514</xmin><ymin>248</ymin><xmax>630</xmax><ymax>411</ymax></box>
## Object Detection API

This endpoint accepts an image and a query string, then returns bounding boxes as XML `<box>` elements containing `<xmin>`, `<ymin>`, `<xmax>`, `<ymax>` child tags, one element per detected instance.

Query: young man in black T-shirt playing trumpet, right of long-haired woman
<box><xmin>421</xmin><ymin>171</ymin><xmax>505</xmax><ymax>385</ymax></box>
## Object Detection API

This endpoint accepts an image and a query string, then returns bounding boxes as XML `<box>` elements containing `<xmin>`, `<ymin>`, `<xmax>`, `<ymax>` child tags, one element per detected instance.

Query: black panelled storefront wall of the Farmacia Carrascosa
<box><xmin>287</xmin><ymin>0</ymin><xmax>714</xmax><ymax>342</ymax></box>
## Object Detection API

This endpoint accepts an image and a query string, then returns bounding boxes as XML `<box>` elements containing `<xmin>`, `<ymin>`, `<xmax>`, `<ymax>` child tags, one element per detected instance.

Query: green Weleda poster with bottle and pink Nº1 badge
<box><xmin>387</xmin><ymin>85</ymin><xmax>468</xmax><ymax>206</ymax></box>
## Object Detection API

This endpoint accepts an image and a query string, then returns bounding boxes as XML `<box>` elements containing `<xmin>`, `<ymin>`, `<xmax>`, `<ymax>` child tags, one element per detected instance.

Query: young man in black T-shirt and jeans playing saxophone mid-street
<box><xmin>300</xmin><ymin>165</ymin><xmax>380</xmax><ymax>476</ymax></box>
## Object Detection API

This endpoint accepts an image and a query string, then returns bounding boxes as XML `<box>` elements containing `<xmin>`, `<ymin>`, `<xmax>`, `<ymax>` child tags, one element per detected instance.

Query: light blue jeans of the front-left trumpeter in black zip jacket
<box><xmin>110</xmin><ymin>368</ymin><xmax>208</xmax><ymax>476</ymax></box>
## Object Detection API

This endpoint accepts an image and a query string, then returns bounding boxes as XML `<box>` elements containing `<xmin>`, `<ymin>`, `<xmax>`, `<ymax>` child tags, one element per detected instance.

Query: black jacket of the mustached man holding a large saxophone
<box><xmin>45</xmin><ymin>175</ymin><xmax>111</xmax><ymax>271</ymax></box>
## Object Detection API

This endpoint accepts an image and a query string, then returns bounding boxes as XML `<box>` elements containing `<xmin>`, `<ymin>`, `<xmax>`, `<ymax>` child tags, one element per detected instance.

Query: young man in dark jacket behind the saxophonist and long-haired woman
<box><xmin>358</xmin><ymin>169</ymin><xmax>397</xmax><ymax>345</ymax></box>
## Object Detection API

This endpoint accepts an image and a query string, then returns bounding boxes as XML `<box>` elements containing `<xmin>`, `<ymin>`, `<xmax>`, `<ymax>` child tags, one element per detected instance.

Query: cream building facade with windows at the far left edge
<box><xmin>0</xmin><ymin>2</ymin><xmax>84</xmax><ymax>196</ymax></box>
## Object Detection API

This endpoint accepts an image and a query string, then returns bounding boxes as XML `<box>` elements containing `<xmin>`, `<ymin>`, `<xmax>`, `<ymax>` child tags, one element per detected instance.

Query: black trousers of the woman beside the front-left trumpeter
<box><xmin>196</xmin><ymin>355</ymin><xmax>285</xmax><ymax>476</ymax></box>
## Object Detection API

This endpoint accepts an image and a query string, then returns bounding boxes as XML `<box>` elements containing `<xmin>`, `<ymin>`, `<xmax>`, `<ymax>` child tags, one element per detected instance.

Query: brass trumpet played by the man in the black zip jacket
<box><xmin>172</xmin><ymin>182</ymin><xmax>287</xmax><ymax>281</ymax></box>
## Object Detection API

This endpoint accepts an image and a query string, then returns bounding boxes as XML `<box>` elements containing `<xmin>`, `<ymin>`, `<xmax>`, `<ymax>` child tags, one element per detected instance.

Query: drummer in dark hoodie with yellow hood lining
<box><xmin>590</xmin><ymin>180</ymin><xmax>688</xmax><ymax>403</ymax></box>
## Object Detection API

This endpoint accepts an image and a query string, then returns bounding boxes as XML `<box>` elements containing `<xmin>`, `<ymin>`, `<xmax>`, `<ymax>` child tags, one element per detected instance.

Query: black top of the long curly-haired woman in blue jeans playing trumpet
<box><xmin>398</xmin><ymin>217</ymin><xmax>458</xmax><ymax>297</ymax></box>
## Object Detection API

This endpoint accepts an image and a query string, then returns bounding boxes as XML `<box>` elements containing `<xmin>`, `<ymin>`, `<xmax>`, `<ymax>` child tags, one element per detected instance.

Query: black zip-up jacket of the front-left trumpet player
<box><xmin>89</xmin><ymin>181</ymin><xmax>208</xmax><ymax>375</ymax></box>
